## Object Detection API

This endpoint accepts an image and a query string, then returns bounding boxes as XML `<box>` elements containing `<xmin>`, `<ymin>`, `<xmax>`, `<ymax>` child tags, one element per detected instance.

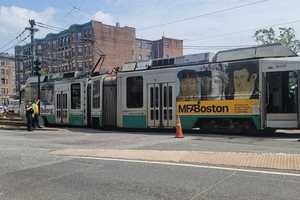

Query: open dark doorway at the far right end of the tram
<box><xmin>264</xmin><ymin>70</ymin><xmax>299</xmax><ymax>128</ymax></box>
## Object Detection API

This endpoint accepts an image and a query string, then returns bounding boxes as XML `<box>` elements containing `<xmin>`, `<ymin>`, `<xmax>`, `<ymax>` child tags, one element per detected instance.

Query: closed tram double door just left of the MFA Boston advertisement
<box><xmin>148</xmin><ymin>83</ymin><xmax>175</xmax><ymax>128</ymax></box>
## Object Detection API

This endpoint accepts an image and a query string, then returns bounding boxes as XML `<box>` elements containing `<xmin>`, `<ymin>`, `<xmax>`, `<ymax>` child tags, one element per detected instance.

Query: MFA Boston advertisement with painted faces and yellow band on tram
<box><xmin>177</xmin><ymin>61</ymin><xmax>259</xmax><ymax>115</ymax></box>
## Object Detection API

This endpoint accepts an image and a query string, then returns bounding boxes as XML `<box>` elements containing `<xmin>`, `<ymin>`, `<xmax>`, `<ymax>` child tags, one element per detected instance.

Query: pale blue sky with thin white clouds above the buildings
<box><xmin>0</xmin><ymin>0</ymin><xmax>300</xmax><ymax>54</ymax></box>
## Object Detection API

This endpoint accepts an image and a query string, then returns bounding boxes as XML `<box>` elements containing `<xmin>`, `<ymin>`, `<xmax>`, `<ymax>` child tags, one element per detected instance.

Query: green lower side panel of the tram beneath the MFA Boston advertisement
<box><xmin>180</xmin><ymin>115</ymin><xmax>261</xmax><ymax>129</ymax></box>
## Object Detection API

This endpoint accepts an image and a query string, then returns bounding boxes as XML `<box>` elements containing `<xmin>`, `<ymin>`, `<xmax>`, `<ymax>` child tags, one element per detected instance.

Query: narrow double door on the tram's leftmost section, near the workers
<box><xmin>56</xmin><ymin>91</ymin><xmax>68</xmax><ymax>124</ymax></box>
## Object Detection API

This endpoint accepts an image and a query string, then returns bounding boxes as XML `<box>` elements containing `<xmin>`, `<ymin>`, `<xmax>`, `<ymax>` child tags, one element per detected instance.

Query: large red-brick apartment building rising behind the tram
<box><xmin>15</xmin><ymin>20</ymin><xmax>183</xmax><ymax>91</ymax></box>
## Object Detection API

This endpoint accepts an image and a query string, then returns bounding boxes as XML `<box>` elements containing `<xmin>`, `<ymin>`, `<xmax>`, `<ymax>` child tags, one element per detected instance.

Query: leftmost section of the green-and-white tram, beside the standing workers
<box><xmin>21</xmin><ymin>72</ymin><xmax>88</xmax><ymax>126</ymax></box>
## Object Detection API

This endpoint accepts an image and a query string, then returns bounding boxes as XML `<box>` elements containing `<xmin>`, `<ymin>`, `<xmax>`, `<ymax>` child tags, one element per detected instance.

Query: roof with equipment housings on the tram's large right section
<box><xmin>119</xmin><ymin>44</ymin><xmax>298</xmax><ymax>73</ymax></box>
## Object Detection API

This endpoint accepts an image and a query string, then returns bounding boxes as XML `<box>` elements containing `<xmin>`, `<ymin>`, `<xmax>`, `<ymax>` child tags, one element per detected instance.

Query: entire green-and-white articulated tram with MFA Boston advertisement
<box><xmin>21</xmin><ymin>45</ymin><xmax>300</xmax><ymax>130</ymax></box>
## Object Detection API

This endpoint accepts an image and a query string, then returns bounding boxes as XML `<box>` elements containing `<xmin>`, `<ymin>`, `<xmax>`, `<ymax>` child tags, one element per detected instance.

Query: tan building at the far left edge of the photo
<box><xmin>0</xmin><ymin>54</ymin><xmax>15</xmax><ymax>105</ymax></box>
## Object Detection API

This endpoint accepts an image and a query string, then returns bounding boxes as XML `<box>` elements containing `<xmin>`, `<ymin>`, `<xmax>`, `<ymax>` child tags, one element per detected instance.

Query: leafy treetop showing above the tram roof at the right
<box><xmin>254</xmin><ymin>27</ymin><xmax>300</xmax><ymax>52</ymax></box>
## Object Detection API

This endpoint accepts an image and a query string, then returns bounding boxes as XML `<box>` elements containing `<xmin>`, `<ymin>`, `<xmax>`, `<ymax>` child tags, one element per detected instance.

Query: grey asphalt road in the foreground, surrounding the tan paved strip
<box><xmin>0</xmin><ymin>129</ymin><xmax>300</xmax><ymax>200</ymax></box>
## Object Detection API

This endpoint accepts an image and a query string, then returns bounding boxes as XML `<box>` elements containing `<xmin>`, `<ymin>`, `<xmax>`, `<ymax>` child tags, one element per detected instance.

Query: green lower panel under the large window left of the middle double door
<box><xmin>123</xmin><ymin>115</ymin><xmax>147</xmax><ymax>128</ymax></box>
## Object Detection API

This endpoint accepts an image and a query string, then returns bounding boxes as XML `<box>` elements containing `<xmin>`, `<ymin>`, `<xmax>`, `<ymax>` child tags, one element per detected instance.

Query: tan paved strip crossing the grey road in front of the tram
<box><xmin>51</xmin><ymin>149</ymin><xmax>300</xmax><ymax>171</ymax></box>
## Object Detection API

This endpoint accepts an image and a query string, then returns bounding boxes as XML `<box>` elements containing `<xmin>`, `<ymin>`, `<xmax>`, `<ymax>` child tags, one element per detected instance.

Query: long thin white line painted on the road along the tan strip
<box><xmin>68</xmin><ymin>156</ymin><xmax>300</xmax><ymax>177</ymax></box>
